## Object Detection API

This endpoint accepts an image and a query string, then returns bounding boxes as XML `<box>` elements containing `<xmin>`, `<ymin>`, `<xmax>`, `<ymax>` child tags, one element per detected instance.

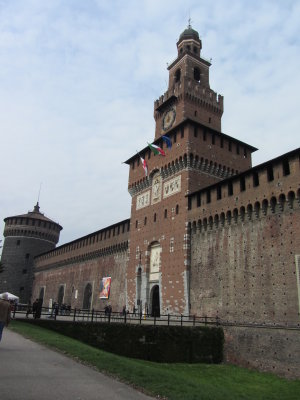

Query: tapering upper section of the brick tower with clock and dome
<box><xmin>154</xmin><ymin>25</ymin><xmax>223</xmax><ymax>139</ymax></box>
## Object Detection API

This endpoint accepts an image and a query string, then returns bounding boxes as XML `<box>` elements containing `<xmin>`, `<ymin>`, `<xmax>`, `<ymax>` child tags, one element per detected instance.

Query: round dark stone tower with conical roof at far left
<box><xmin>0</xmin><ymin>203</ymin><xmax>62</xmax><ymax>303</ymax></box>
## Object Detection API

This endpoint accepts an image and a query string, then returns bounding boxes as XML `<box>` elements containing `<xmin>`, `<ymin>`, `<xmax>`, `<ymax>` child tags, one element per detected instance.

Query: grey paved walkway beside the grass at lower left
<box><xmin>0</xmin><ymin>328</ymin><xmax>153</xmax><ymax>400</ymax></box>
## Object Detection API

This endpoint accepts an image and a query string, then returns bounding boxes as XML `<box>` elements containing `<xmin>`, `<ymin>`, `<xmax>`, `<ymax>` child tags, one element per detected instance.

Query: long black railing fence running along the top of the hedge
<box><xmin>12</xmin><ymin>304</ymin><xmax>220</xmax><ymax>326</ymax></box>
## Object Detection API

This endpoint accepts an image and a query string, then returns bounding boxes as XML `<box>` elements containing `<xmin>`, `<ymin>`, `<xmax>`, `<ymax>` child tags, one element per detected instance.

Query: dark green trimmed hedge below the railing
<box><xmin>22</xmin><ymin>320</ymin><xmax>224</xmax><ymax>363</ymax></box>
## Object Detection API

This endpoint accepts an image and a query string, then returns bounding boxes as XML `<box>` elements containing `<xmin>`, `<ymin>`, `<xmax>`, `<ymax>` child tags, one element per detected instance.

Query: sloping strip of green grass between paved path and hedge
<box><xmin>10</xmin><ymin>321</ymin><xmax>300</xmax><ymax>400</ymax></box>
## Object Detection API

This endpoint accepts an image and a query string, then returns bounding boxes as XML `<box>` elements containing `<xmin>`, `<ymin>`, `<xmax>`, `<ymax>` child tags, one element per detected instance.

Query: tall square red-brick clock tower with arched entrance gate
<box><xmin>126</xmin><ymin>25</ymin><xmax>256</xmax><ymax>315</ymax></box>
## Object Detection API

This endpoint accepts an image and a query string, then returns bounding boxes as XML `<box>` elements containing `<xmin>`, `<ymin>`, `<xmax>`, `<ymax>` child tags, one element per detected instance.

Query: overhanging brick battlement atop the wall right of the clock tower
<box><xmin>188</xmin><ymin>149</ymin><xmax>300</xmax><ymax>226</ymax></box>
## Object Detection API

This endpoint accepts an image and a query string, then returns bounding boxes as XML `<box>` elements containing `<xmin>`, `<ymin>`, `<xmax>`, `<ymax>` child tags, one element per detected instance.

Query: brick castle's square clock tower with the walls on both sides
<box><xmin>1</xmin><ymin>25</ymin><xmax>300</xmax><ymax>376</ymax></box>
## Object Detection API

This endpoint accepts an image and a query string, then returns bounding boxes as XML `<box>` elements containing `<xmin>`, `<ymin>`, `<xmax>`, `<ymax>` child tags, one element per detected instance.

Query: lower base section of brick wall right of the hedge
<box><xmin>224</xmin><ymin>326</ymin><xmax>300</xmax><ymax>378</ymax></box>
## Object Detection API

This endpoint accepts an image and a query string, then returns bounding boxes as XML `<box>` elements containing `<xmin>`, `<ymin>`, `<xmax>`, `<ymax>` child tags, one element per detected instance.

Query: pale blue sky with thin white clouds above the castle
<box><xmin>0</xmin><ymin>0</ymin><xmax>300</xmax><ymax>244</ymax></box>
